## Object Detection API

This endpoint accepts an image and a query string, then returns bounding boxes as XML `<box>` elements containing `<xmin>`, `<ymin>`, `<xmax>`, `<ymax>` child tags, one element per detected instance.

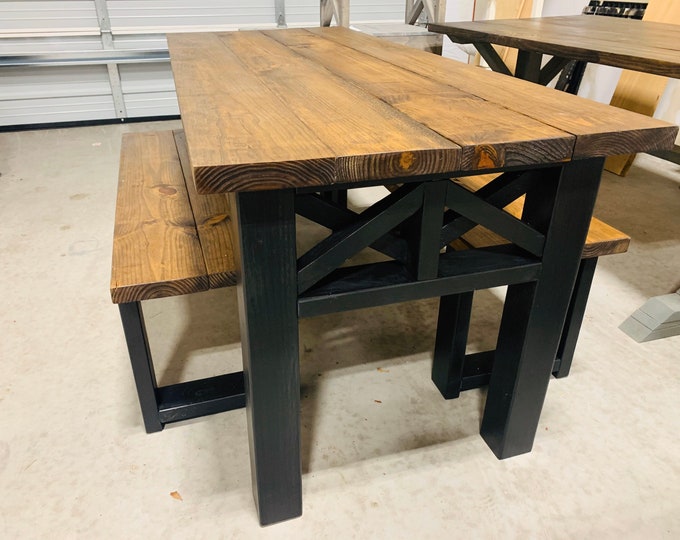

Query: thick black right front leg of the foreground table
<box><xmin>481</xmin><ymin>158</ymin><xmax>604</xmax><ymax>459</ymax></box>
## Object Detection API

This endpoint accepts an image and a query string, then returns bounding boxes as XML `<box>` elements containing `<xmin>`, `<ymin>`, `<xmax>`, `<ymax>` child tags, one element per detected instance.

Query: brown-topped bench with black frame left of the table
<box><xmin>111</xmin><ymin>131</ymin><xmax>244</xmax><ymax>433</ymax></box>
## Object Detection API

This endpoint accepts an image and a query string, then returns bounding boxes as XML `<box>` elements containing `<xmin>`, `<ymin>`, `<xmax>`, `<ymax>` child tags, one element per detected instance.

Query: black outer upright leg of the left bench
<box><xmin>118</xmin><ymin>302</ymin><xmax>163</xmax><ymax>433</ymax></box>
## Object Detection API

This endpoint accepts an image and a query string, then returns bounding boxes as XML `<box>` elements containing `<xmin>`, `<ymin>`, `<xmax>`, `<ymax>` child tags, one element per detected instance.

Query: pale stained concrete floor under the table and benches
<box><xmin>0</xmin><ymin>123</ymin><xmax>680</xmax><ymax>539</ymax></box>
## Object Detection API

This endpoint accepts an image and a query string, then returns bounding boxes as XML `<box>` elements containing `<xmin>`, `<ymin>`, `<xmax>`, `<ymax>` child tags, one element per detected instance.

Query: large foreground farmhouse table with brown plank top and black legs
<box><xmin>168</xmin><ymin>28</ymin><xmax>677</xmax><ymax>524</ymax></box>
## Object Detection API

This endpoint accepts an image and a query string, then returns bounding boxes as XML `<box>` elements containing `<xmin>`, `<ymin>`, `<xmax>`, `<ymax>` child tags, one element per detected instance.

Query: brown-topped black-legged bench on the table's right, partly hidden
<box><xmin>432</xmin><ymin>175</ymin><xmax>630</xmax><ymax>399</ymax></box>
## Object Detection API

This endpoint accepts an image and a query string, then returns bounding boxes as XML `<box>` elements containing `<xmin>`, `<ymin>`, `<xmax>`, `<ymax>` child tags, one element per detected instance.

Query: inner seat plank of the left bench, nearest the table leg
<box><xmin>174</xmin><ymin>130</ymin><xmax>236</xmax><ymax>289</ymax></box>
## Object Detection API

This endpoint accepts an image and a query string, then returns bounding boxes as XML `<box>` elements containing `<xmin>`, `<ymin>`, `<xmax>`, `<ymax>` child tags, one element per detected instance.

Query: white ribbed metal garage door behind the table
<box><xmin>0</xmin><ymin>0</ymin><xmax>405</xmax><ymax>126</ymax></box>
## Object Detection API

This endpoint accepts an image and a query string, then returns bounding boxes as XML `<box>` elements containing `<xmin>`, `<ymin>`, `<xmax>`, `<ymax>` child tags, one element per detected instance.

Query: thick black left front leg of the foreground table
<box><xmin>230</xmin><ymin>190</ymin><xmax>302</xmax><ymax>525</ymax></box>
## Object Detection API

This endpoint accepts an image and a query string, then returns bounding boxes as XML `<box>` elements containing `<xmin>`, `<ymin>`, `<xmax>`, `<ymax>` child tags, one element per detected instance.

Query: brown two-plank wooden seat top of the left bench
<box><xmin>111</xmin><ymin>131</ymin><xmax>235</xmax><ymax>303</ymax></box>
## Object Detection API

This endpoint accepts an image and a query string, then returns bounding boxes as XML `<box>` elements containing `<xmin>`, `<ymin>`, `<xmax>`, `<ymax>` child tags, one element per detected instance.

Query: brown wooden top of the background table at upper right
<box><xmin>428</xmin><ymin>15</ymin><xmax>680</xmax><ymax>78</ymax></box>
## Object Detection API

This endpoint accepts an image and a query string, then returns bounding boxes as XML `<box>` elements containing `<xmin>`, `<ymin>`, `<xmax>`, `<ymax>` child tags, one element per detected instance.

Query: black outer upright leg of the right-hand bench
<box><xmin>553</xmin><ymin>257</ymin><xmax>597</xmax><ymax>378</ymax></box>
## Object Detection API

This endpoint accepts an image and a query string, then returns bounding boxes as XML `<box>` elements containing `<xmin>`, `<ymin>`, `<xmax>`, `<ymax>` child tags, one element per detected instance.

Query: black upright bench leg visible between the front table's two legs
<box><xmin>432</xmin><ymin>292</ymin><xmax>473</xmax><ymax>399</ymax></box>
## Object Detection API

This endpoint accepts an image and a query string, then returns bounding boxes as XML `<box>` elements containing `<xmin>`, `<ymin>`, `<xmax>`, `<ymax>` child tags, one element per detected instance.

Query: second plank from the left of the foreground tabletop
<box><xmin>220</xmin><ymin>32</ymin><xmax>461</xmax><ymax>186</ymax></box>
